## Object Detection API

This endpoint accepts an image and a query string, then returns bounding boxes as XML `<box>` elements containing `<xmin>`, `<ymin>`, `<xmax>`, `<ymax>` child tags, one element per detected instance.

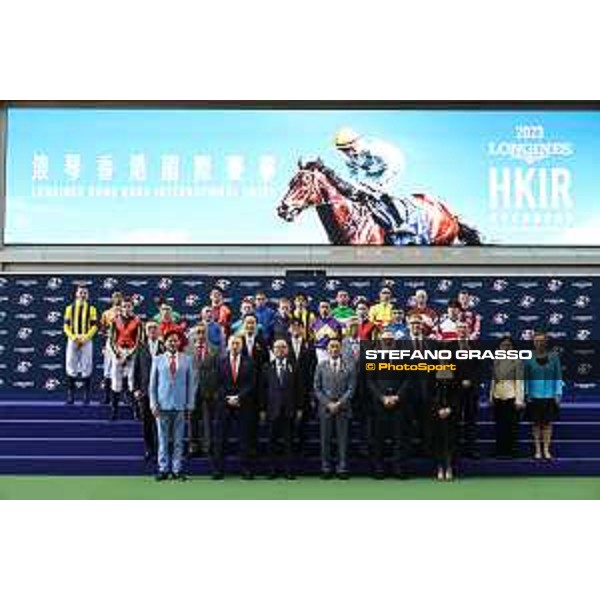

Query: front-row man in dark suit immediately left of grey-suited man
<box><xmin>261</xmin><ymin>339</ymin><xmax>302</xmax><ymax>479</ymax></box>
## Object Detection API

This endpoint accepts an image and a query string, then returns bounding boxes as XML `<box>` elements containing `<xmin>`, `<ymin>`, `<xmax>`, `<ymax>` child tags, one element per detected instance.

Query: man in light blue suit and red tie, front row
<box><xmin>148</xmin><ymin>331</ymin><xmax>195</xmax><ymax>481</ymax></box>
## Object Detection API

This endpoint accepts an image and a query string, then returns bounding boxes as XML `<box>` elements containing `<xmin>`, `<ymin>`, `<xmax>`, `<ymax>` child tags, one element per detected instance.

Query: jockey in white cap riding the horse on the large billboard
<box><xmin>335</xmin><ymin>127</ymin><xmax>431</xmax><ymax>245</ymax></box>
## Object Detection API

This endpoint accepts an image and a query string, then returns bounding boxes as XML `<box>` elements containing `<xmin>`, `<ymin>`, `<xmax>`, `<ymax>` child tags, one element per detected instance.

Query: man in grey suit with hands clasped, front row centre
<box><xmin>314</xmin><ymin>338</ymin><xmax>356</xmax><ymax>479</ymax></box>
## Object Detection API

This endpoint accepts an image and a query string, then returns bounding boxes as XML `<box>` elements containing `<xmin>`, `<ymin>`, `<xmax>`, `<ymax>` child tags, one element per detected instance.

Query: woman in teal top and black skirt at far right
<box><xmin>525</xmin><ymin>332</ymin><xmax>563</xmax><ymax>460</ymax></box>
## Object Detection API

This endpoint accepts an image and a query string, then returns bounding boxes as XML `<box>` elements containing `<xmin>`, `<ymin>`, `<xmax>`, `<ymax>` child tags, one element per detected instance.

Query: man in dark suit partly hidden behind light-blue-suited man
<box><xmin>133</xmin><ymin>321</ymin><xmax>165</xmax><ymax>462</ymax></box>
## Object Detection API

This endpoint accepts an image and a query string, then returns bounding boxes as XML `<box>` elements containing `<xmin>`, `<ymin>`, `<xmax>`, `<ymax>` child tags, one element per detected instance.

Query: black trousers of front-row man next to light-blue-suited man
<box><xmin>212</xmin><ymin>404</ymin><xmax>256</xmax><ymax>473</ymax></box>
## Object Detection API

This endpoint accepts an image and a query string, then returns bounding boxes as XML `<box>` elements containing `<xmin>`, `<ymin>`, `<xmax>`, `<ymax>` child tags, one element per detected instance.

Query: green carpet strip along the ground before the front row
<box><xmin>0</xmin><ymin>476</ymin><xmax>600</xmax><ymax>500</ymax></box>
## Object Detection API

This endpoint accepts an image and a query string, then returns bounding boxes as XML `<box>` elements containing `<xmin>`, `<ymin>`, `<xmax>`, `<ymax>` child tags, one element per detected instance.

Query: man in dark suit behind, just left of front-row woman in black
<box><xmin>398</xmin><ymin>314</ymin><xmax>436</xmax><ymax>456</ymax></box>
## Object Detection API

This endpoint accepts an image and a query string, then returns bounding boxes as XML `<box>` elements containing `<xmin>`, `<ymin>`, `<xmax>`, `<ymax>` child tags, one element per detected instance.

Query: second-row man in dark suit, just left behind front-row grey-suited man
<box><xmin>288</xmin><ymin>319</ymin><xmax>317</xmax><ymax>454</ymax></box>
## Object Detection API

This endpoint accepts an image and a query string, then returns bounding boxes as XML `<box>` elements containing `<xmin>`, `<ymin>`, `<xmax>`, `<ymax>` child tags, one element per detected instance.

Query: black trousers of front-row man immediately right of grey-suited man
<box><xmin>373</xmin><ymin>401</ymin><xmax>411</xmax><ymax>472</ymax></box>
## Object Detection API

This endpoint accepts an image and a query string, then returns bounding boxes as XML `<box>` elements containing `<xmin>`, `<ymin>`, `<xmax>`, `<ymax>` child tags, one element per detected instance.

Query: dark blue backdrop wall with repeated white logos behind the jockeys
<box><xmin>0</xmin><ymin>274</ymin><xmax>600</xmax><ymax>398</ymax></box>
